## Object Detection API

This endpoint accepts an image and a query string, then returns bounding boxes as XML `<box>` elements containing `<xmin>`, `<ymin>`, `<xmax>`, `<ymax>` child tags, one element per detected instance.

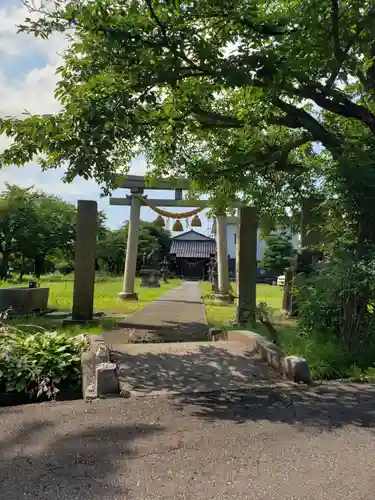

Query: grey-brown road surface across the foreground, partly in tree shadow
<box><xmin>0</xmin><ymin>385</ymin><xmax>375</xmax><ymax>500</ymax></box>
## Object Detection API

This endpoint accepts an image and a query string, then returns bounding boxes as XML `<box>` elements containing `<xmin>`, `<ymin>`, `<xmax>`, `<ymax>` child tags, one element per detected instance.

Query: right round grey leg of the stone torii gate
<box><xmin>216</xmin><ymin>215</ymin><xmax>230</xmax><ymax>301</ymax></box>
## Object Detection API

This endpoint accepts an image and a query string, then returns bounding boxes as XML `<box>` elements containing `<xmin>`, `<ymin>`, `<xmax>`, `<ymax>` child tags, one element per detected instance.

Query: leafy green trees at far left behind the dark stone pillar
<box><xmin>0</xmin><ymin>184</ymin><xmax>105</xmax><ymax>280</ymax></box>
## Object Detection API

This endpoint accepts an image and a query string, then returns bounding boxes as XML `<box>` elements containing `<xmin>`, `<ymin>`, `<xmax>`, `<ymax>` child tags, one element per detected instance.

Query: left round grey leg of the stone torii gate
<box><xmin>119</xmin><ymin>188</ymin><xmax>143</xmax><ymax>300</ymax></box>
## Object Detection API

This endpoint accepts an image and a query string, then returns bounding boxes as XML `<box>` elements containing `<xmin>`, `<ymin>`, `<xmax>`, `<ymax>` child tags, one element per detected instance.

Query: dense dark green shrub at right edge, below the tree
<box><xmin>296</xmin><ymin>253</ymin><xmax>375</xmax><ymax>360</ymax></box>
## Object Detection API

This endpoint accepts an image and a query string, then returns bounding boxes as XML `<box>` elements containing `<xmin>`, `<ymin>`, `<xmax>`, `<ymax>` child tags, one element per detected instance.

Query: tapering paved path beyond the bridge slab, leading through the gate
<box><xmin>104</xmin><ymin>282</ymin><xmax>208</xmax><ymax>345</ymax></box>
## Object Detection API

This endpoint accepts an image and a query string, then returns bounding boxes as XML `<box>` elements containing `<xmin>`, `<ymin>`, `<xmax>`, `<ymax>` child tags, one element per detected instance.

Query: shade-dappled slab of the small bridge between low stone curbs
<box><xmin>111</xmin><ymin>341</ymin><xmax>281</xmax><ymax>396</ymax></box>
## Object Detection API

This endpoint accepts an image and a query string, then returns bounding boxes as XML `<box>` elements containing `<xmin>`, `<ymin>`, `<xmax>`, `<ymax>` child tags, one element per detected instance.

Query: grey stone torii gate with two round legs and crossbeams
<box><xmin>110</xmin><ymin>175</ymin><xmax>230</xmax><ymax>300</ymax></box>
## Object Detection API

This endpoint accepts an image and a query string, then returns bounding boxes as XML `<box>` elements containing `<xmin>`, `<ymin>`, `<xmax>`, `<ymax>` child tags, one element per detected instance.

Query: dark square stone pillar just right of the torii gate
<box><xmin>236</xmin><ymin>207</ymin><xmax>258</xmax><ymax>325</ymax></box>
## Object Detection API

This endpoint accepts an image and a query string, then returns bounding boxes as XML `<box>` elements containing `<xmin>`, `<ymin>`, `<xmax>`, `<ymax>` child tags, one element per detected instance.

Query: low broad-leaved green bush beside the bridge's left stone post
<box><xmin>0</xmin><ymin>325</ymin><xmax>87</xmax><ymax>398</ymax></box>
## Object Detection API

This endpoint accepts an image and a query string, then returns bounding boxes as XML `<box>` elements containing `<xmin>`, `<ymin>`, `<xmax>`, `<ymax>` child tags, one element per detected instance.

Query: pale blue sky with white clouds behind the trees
<box><xmin>0</xmin><ymin>0</ymin><xmax>209</xmax><ymax>233</ymax></box>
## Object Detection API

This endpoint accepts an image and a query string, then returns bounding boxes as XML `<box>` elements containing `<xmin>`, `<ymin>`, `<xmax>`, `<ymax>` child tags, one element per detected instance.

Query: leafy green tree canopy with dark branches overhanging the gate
<box><xmin>0</xmin><ymin>0</ymin><xmax>375</xmax><ymax>210</ymax></box>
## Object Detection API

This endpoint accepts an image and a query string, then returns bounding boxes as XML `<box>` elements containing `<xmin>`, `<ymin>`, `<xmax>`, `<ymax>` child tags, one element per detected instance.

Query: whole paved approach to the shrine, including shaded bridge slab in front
<box><xmin>104</xmin><ymin>282</ymin><xmax>280</xmax><ymax>396</ymax></box>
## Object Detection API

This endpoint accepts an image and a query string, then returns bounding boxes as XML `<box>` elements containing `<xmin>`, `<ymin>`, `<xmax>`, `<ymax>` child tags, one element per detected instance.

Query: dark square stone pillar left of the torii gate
<box><xmin>72</xmin><ymin>200</ymin><xmax>98</xmax><ymax>323</ymax></box>
